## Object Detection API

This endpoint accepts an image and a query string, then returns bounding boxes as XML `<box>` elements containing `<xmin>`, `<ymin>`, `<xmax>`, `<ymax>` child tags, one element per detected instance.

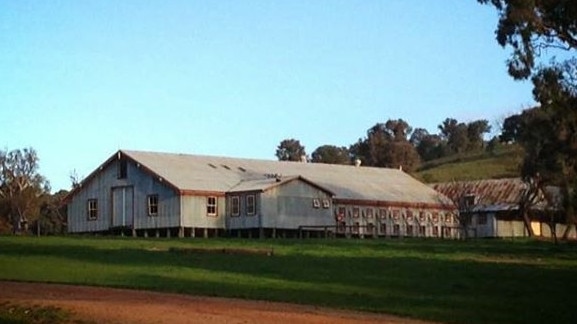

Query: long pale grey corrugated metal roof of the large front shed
<box><xmin>120</xmin><ymin>150</ymin><xmax>452</xmax><ymax>205</ymax></box>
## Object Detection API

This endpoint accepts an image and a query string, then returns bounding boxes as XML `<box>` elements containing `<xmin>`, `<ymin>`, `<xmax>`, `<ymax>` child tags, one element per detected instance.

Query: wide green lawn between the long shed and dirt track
<box><xmin>0</xmin><ymin>237</ymin><xmax>577</xmax><ymax>323</ymax></box>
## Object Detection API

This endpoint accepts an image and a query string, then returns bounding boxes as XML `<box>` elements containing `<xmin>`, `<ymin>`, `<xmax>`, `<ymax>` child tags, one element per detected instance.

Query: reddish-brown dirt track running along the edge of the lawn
<box><xmin>0</xmin><ymin>281</ymin><xmax>432</xmax><ymax>324</ymax></box>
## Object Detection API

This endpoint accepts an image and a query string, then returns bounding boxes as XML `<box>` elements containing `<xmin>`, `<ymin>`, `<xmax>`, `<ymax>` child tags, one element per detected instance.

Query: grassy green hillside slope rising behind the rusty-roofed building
<box><xmin>413</xmin><ymin>145</ymin><xmax>523</xmax><ymax>183</ymax></box>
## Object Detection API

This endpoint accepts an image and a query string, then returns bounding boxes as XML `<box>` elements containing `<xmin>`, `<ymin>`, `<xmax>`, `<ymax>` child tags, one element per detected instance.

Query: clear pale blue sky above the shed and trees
<box><xmin>0</xmin><ymin>0</ymin><xmax>533</xmax><ymax>190</ymax></box>
